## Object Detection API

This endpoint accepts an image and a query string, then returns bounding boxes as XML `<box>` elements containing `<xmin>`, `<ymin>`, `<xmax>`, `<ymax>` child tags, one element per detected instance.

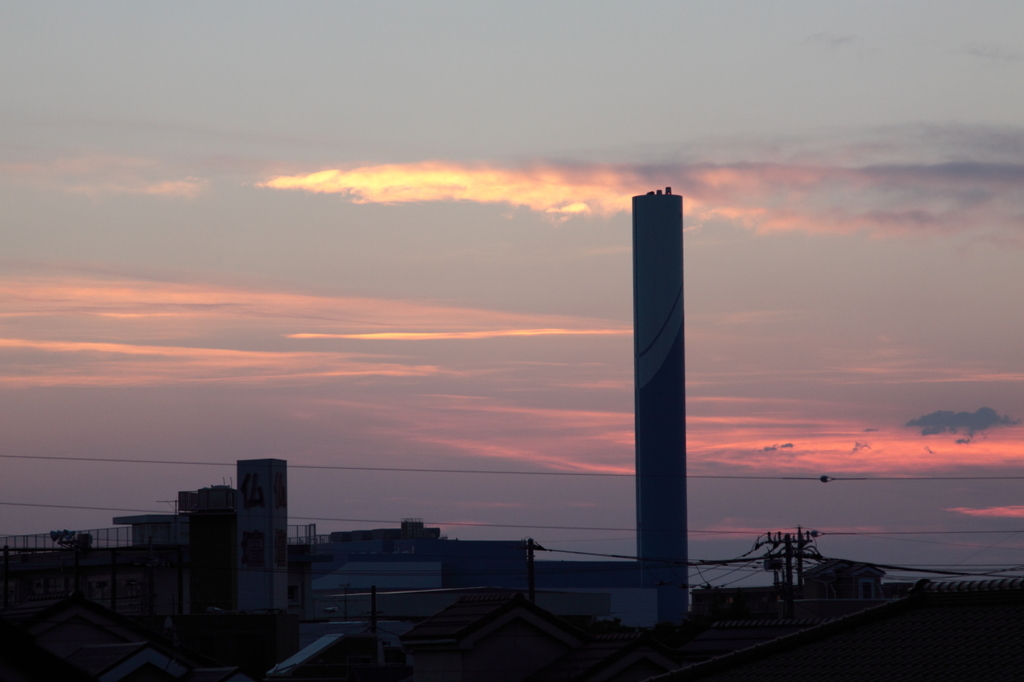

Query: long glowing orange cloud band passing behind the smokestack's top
<box><xmin>259</xmin><ymin>161</ymin><xmax>1024</xmax><ymax>233</ymax></box>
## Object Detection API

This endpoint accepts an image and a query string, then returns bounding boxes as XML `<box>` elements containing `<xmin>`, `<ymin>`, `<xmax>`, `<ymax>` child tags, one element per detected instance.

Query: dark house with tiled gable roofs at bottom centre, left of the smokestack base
<box><xmin>401</xmin><ymin>593</ymin><xmax>679</xmax><ymax>682</ymax></box>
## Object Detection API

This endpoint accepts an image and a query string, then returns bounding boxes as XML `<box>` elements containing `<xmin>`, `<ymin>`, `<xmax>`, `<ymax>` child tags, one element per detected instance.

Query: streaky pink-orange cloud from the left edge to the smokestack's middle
<box><xmin>0</xmin><ymin>270</ymin><xmax>629</xmax><ymax>387</ymax></box>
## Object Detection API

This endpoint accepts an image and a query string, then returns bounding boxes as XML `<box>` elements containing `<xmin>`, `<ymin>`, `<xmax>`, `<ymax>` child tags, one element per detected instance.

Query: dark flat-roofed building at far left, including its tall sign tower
<box><xmin>0</xmin><ymin>460</ymin><xmax>324</xmax><ymax>617</ymax></box>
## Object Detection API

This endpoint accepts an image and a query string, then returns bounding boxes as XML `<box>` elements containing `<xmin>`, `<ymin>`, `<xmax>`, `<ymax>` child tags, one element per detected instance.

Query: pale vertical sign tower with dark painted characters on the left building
<box><xmin>238</xmin><ymin>460</ymin><xmax>288</xmax><ymax>611</ymax></box>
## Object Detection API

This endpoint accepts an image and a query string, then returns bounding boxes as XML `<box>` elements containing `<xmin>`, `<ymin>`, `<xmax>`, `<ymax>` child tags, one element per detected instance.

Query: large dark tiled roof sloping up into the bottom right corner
<box><xmin>652</xmin><ymin>579</ymin><xmax>1024</xmax><ymax>682</ymax></box>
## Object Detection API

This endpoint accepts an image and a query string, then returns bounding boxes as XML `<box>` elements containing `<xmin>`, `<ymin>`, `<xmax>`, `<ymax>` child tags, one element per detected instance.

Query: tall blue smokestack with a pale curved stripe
<box><xmin>633</xmin><ymin>187</ymin><xmax>688</xmax><ymax>623</ymax></box>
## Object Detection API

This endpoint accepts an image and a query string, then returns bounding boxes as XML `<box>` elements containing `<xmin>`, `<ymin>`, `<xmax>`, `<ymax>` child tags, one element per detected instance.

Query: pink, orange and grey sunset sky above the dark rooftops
<box><xmin>0</xmin><ymin>0</ymin><xmax>1024</xmax><ymax>582</ymax></box>
